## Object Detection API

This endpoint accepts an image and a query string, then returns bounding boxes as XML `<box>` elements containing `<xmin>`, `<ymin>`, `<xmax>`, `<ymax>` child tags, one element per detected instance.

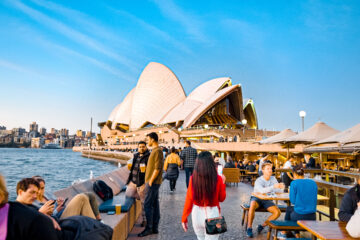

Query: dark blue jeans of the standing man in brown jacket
<box><xmin>144</xmin><ymin>183</ymin><xmax>160</xmax><ymax>230</ymax></box>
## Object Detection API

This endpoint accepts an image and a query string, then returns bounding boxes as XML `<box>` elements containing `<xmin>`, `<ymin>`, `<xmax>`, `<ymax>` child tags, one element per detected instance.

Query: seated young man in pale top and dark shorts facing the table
<box><xmin>246</xmin><ymin>162</ymin><xmax>284</xmax><ymax>238</ymax></box>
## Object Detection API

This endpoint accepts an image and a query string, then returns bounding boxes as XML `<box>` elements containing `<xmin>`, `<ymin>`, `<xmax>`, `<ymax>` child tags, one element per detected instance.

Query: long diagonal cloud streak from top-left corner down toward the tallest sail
<box><xmin>10</xmin><ymin>0</ymin><xmax>138</xmax><ymax>72</ymax></box>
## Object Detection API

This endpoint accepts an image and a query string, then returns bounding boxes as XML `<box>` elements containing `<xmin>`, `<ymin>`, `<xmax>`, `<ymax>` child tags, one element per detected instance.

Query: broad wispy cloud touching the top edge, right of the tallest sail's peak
<box><xmin>153</xmin><ymin>0</ymin><xmax>210</xmax><ymax>43</ymax></box>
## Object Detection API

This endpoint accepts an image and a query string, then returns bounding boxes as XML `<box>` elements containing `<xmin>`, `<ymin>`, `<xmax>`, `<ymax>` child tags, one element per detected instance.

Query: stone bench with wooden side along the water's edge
<box><xmin>54</xmin><ymin>167</ymin><xmax>142</xmax><ymax>240</ymax></box>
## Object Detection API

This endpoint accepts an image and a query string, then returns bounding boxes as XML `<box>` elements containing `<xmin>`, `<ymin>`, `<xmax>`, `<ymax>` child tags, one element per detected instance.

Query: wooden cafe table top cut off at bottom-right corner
<box><xmin>297</xmin><ymin>220</ymin><xmax>356</xmax><ymax>240</ymax></box>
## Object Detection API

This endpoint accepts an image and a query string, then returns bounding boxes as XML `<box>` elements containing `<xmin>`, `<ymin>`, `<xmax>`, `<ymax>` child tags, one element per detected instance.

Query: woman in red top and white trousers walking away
<box><xmin>181</xmin><ymin>152</ymin><xmax>226</xmax><ymax>239</ymax></box>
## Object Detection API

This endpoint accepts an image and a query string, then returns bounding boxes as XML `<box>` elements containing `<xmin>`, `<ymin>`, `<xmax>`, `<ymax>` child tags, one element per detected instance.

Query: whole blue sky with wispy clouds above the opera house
<box><xmin>0</xmin><ymin>0</ymin><xmax>360</xmax><ymax>132</ymax></box>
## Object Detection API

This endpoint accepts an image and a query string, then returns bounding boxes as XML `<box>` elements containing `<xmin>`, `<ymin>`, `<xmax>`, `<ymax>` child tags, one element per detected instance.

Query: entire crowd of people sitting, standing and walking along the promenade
<box><xmin>0</xmin><ymin>135</ymin><xmax>360</xmax><ymax>240</ymax></box>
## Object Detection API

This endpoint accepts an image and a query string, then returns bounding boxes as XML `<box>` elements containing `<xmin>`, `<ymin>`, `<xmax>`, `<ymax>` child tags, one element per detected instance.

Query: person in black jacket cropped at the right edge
<box><xmin>338</xmin><ymin>179</ymin><xmax>360</xmax><ymax>222</ymax></box>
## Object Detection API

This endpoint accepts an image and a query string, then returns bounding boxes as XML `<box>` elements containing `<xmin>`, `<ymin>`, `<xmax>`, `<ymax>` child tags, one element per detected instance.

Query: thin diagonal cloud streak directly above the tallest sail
<box><xmin>113</xmin><ymin>9</ymin><xmax>192</xmax><ymax>54</ymax></box>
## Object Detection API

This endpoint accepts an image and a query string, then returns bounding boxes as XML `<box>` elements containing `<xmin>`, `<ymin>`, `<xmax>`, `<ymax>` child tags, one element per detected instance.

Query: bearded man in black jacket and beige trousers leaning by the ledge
<box><xmin>125</xmin><ymin>141</ymin><xmax>150</xmax><ymax>226</ymax></box>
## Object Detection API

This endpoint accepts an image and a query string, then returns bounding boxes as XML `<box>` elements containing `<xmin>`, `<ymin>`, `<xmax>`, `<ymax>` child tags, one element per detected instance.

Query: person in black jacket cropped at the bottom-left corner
<box><xmin>0</xmin><ymin>175</ymin><xmax>62</xmax><ymax>240</ymax></box>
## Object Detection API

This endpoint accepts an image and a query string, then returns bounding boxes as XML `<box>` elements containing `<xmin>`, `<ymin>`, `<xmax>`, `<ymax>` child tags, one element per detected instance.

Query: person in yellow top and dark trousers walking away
<box><xmin>164</xmin><ymin>147</ymin><xmax>181</xmax><ymax>192</ymax></box>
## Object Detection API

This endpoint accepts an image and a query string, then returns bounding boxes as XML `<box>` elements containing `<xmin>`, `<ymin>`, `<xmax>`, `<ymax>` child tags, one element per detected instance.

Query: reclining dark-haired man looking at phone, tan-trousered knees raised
<box><xmin>16</xmin><ymin>178</ymin><xmax>101</xmax><ymax>221</ymax></box>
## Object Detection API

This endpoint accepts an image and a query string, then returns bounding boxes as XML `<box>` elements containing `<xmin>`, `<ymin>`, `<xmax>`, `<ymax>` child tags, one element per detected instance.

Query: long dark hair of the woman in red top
<box><xmin>192</xmin><ymin>152</ymin><xmax>217</xmax><ymax>202</ymax></box>
